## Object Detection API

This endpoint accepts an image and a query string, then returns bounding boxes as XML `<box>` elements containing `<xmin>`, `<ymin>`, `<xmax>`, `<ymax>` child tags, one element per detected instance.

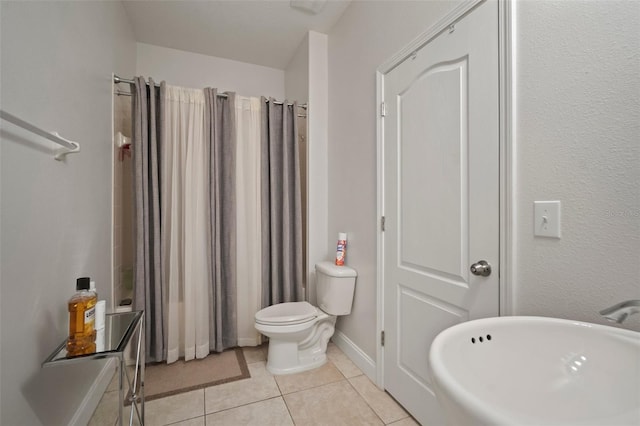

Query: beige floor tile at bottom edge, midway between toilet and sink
<box><xmin>284</xmin><ymin>380</ymin><xmax>383</xmax><ymax>426</ymax></box>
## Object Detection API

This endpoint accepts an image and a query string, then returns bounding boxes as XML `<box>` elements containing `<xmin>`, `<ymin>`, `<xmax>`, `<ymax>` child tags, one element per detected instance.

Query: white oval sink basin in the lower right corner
<box><xmin>429</xmin><ymin>316</ymin><xmax>640</xmax><ymax>426</ymax></box>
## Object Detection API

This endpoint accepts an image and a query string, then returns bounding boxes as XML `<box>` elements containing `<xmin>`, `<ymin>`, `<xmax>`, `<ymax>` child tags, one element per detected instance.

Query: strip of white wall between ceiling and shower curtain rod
<box><xmin>136</xmin><ymin>43</ymin><xmax>285</xmax><ymax>100</ymax></box>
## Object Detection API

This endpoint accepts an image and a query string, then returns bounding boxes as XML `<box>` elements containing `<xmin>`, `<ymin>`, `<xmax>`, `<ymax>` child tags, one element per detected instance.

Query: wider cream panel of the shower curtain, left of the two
<box><xmin>165</xmin><ymin>86</ymin><xmax>211</xmax><ymax>363</ymax></box>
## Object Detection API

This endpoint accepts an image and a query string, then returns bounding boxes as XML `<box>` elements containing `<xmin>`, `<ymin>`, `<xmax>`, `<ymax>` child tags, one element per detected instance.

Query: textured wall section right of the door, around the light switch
<box><xmin>514</xmin><ymin>1</ymin><xmax>640</xmax><ymax>330</ymax></box>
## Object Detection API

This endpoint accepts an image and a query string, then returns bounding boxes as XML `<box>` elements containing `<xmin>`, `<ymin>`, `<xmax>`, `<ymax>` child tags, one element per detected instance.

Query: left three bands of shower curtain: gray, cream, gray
<box><xmin>133</xmin><ymin>77</ymin><xmax>237</xmax><ymax>362</ymax></box>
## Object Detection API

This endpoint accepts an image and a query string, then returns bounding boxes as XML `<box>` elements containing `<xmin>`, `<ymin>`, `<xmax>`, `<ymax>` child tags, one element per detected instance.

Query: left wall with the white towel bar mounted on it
<box><xmin>0</xmin><ymin>2</ymin><xmax>135</xmax><ymax>425</ymax></box>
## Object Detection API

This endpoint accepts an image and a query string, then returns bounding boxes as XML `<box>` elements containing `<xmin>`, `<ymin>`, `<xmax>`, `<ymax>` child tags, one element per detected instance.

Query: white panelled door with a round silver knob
<box><xmin>383</xmin><ymin>2</ymin><xmax>499</xmax><ymax>425</ymax></box>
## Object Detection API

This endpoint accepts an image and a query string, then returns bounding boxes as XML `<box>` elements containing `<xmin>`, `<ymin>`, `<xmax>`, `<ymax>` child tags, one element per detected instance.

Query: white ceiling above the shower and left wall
<box><xmin>123</xmin><ymin>0</ymin><xmax>350</xmax><ymax>69</ymax></box>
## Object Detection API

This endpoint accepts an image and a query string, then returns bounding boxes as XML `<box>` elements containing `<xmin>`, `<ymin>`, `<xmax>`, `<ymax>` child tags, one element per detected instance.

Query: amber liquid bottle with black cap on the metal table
<box><xmin>67</xmin><ymin>277</ymin><xmax>98</xmax><ymax>356</ymax></box>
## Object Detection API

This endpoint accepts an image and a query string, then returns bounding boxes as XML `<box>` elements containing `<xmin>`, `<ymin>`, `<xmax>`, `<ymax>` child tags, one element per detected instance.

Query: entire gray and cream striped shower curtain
<box><xmin>133</xmin><ymin>77</ymin><xmax>303</xmax><ymax>362</ymax></box>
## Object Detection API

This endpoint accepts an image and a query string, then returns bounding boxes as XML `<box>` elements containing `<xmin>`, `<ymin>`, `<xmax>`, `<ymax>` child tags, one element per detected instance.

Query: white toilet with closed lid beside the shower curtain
<box><xmin>255</xmin><ymin>262</ymin><xmax>357</xmax><ymax>374</ymax></box>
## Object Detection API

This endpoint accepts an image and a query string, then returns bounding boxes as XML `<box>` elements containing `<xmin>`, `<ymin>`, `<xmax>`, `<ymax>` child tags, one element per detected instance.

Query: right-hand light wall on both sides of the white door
<box><xmin>328</xmin><ymin>1</ymin><xmax>640</xmax><ymax>370</ymax></box>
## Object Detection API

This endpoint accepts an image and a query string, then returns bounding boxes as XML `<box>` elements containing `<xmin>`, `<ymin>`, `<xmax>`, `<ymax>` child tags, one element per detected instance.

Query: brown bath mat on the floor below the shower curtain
<box><xmin>127</xmin><ymin>348</ymin><xmax>251</xmax><ymax>405</ymax></box>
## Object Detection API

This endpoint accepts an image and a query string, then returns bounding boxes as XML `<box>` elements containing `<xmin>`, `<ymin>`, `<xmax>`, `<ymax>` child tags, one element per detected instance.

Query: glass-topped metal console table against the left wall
<box><xmin>42</xmin><ymin>311</ymin><xmax>145</xmax><ymax>426</ymax></box>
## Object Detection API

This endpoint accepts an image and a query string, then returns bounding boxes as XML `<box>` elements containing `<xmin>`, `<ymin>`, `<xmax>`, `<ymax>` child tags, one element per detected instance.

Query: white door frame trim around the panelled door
<box><xmin>376</xmin><ymin>0</ymin><xmax>516</xmax><ymax>389</ymax></box>
